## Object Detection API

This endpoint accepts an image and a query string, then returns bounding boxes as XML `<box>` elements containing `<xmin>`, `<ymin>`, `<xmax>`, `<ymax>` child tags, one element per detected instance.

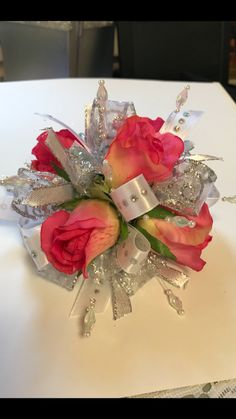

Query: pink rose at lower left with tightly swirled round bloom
<box><xmin>41</xmin><ymin>199</ymin><xmax>120</xmax><ymax>277</ymax></box>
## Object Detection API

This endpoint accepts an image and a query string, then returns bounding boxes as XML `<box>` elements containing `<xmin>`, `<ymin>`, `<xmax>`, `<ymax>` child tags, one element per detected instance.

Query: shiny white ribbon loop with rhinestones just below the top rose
<box><xmin>111</xmin><ymin>175</ymin><xmax>159</xmax><ymax>221</ymax></box>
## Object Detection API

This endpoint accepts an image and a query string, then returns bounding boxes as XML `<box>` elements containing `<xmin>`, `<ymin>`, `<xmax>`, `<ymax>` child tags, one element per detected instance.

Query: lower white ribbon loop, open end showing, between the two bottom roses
<box><xmin>117</xmin><ymin>227</ymin><xmax>151</xmax><ymax>274</ymax></box>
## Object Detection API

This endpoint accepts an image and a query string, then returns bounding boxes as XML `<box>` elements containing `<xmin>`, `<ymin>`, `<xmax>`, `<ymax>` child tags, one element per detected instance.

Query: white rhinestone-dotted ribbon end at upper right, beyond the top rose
<box><xmin>160</xmin><ymin>111</ymin><xmax>203</xmax><ymax>140</ymax></box>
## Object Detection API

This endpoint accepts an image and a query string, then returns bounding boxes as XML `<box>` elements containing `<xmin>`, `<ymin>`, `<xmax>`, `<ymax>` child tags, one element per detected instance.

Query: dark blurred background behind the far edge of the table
<box><xmin>0</xmin><ymin>21</ymin><xmax>236</xmax><ymax>101</ymax></box>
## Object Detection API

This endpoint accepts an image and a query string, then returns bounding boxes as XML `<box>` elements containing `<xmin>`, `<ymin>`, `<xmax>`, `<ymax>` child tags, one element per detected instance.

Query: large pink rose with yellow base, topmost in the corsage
<box><xmin>105</xmin><ymin>115</ymin><xmax>184</xmax><ymax>188</ymax></box>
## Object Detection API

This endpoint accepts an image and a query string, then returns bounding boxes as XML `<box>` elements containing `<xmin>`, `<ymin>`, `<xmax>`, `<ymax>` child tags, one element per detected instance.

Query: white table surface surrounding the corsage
<box><xmin>0</xmin><ymin>79</ymin><xmax>236</xmax><ymax>397</ymax></box>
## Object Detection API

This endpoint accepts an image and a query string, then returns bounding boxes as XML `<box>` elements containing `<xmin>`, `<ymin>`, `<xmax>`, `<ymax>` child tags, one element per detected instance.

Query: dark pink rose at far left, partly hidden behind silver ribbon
<box><xmin>31</xmin><ymin>129</ymin><xmax>76</xmax><ymax>173</ymax></box>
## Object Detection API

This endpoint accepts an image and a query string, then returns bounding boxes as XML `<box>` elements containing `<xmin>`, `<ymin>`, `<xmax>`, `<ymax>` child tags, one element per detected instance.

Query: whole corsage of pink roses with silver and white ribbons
<box><xmin>0</xmin><ymin>82</ymin><xmax>219</xmax><ymax>332</ymax></box>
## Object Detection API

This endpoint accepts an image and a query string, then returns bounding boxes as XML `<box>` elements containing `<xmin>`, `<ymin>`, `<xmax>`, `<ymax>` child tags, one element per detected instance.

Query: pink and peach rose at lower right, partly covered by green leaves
<box><xmin>138</xmin><ymin>204</ymin><xmax>213</xmax><ymax>271</ymax></box>
